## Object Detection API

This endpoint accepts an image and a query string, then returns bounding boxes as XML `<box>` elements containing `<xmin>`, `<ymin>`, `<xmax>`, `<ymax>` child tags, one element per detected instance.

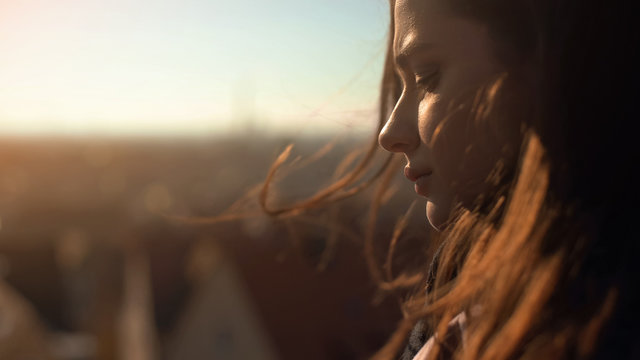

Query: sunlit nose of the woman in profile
<box><xmin>378</xmin><ymin>94</ymin><xmax>420</xmax><ymax>153</ymax></box>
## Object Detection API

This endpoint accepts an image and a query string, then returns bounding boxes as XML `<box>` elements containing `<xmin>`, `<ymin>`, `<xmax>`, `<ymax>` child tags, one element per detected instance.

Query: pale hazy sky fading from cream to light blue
<box><xmin>0</xmin><ymin>0</ymin><xmax>388</xmax><ymax>135</ymax></box>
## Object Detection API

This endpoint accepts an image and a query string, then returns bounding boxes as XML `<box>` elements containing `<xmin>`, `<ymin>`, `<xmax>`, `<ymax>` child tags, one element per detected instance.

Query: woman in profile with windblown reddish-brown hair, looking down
<box><xmin>263</xmin><ymin>0</ymin><xmax>640</xmax><ymax>360</ymax></box>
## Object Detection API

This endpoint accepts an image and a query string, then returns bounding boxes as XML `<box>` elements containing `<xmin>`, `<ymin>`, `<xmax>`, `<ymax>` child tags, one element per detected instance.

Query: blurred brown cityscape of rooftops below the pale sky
<box><xmin>0</xmin><ymin>133</ymin><xmax>427</xmax><ymax>360</ymax></box>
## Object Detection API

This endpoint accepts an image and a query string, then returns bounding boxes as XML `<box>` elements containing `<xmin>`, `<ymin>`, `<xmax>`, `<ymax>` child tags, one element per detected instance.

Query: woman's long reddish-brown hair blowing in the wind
<box><xmin>261</xmin><ymin>0</ymin><xmax>640</xmax><ymax>359</ymax></box>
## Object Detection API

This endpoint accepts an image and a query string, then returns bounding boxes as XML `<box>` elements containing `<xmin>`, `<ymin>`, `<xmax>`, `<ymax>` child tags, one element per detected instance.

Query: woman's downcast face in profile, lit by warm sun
<box><xmin>379</xmin><ymin>0</ymin><xmax>519</xmax><ymax>229</ymax></box>
